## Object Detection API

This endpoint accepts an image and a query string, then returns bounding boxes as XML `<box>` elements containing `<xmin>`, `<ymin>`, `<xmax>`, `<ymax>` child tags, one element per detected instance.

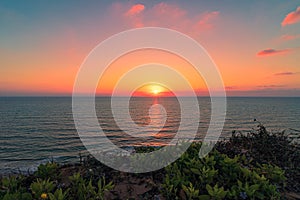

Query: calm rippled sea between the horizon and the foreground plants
<box><xmin>0</xmin><ymin>97</ymin><xmax>300</xmax><ymax>173</ymax></box>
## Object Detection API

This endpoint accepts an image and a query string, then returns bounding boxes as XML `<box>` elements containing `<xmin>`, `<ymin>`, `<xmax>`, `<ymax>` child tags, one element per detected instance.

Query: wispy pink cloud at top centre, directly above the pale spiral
<box><xmin>118</xmin><ymin>2</ymin><xmax>220</xmax><ymax>35</ymax></box>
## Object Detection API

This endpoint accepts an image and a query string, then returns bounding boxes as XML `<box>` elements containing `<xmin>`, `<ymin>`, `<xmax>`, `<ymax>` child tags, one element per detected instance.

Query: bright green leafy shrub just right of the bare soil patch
<box><xmin>162</xmin><ymin>143</ymin><xmax>285</xmax><ymax>199</ymax></box>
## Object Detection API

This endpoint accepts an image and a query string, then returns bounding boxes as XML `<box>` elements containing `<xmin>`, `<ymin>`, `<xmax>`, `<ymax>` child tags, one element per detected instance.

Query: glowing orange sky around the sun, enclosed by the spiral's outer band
<box><xmin>97</xmin><ymin>49</ymin><xmax>206</xmax><ymax>95</ymax></box>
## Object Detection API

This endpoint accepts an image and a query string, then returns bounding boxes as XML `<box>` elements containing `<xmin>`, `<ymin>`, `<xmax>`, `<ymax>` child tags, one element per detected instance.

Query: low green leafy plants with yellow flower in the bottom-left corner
<box><xmin>0</xmin><ymin>173</ymin><xmax>114</xmax><ymax>200</ymax></box>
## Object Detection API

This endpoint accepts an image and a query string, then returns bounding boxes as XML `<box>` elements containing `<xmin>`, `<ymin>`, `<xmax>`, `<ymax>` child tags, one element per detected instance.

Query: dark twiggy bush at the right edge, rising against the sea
<box><xmin>216</xmin><ymin>120</ymin><xmax>300</xmax><ymax>193</ymax></box>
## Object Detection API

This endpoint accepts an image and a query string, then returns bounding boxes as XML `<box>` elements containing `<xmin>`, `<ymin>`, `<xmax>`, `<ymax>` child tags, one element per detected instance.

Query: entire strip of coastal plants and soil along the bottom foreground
<box><xmin>0</xmin><ymin>123</ymin><xmax>300</xmax><ymax>200</ymax></box>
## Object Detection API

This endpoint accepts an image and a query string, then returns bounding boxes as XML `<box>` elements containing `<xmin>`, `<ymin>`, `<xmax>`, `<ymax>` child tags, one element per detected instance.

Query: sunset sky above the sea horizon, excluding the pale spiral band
<box><xmin>0</xmin><ymin>0</ymin><xmax>300</xmax><ymax>96</ymax></box>
